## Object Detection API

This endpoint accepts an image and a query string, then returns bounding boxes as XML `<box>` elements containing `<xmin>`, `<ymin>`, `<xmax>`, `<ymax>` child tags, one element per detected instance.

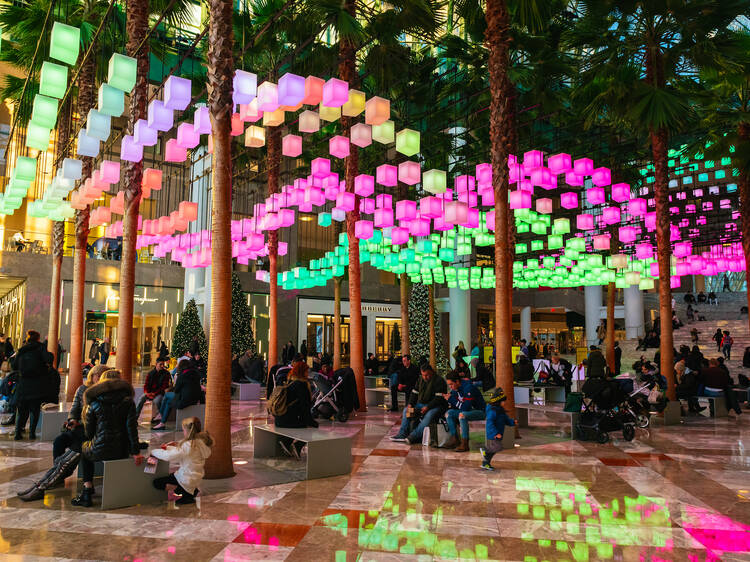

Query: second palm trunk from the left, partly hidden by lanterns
<box><xmin>66</xmin><ymin>48</ymin><xmax>96</xmax><ymax>402</ymax></box>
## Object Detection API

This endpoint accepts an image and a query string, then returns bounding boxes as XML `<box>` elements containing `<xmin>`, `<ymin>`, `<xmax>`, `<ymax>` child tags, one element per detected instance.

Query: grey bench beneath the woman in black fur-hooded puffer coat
<box><xmin>78</xmin><ymin>454</ymin><xmax>169</xmax><ymax>509</ymax></box>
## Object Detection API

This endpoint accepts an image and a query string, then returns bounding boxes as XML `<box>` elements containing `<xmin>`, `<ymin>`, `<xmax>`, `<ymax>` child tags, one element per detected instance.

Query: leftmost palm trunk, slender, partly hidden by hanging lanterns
<box><xmin>47</xmin><ymin>97</ymin><xmax>73</xmax><ymax>365</ymax></box>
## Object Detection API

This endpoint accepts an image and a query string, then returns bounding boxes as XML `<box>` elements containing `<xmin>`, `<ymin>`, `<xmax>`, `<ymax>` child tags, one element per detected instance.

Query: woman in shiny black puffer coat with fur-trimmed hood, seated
<box><xmin>70</xmin><ymin>369</ymin><xmax>143</xmax><ymax>507</ymax></box>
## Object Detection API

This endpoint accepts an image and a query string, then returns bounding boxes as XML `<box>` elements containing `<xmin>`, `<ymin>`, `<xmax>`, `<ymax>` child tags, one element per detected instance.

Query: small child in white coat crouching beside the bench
<box><xmin>151</xmin><ymin>418</ymin><xmax>213</xmax><ymax>505</ymax></box>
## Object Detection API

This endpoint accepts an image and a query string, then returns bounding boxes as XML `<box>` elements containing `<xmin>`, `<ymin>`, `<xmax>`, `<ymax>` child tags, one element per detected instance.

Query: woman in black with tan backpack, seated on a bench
<box><xmin>268</xmin><ymin>361</ymin><xmax>318</xmax><ymax>459</ymax></box>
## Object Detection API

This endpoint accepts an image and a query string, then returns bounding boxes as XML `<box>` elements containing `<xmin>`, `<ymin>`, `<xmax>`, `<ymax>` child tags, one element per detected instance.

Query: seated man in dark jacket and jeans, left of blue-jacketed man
<box><xmin>391</xmin><ymin>363</ymin><xmax>448</xmax><ymax>445</ymax></box>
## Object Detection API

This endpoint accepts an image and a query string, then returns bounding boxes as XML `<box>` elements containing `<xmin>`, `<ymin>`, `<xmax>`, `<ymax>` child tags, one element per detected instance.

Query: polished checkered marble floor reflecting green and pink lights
<box><xmin>0</xmin><ymin>402</ymin><xmax>750</xmax><ymax>562</ymax></box>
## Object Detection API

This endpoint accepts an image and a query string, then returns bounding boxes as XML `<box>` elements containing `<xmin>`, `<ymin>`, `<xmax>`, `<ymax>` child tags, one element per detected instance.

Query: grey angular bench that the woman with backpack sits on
<box><xmin>253</xmin><ymin>424</ymin><xmax>352</xmax><ymax>480</ymax></box>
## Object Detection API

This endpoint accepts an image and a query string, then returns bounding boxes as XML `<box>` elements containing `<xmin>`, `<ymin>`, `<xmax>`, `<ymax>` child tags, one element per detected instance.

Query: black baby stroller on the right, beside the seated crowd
<box><xmin>576</xmin><ymin>379</ymin><xmax>636</xmax><ymax>443</ymax></box>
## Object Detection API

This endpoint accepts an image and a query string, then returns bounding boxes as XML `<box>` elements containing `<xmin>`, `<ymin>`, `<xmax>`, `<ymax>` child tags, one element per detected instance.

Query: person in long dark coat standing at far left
<box><xmin>11</xmin><ymin>330</ymin><xmax>55</xmax><ymax>441</ymax></box>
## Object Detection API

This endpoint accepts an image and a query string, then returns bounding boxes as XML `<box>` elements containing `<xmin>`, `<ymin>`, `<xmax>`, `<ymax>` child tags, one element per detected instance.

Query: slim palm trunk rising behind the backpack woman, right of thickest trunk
<box><xmin>266</xmin><ymin>123</ymin><xmax>281</xmax><ymax>369</ymax></box>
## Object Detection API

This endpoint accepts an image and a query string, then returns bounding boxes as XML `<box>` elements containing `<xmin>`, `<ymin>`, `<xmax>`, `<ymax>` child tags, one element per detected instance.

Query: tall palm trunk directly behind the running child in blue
<box><xmin>485</xmin><ymin>0</ymin><xmax>516</xmax><ymax>417</ymax></box>
